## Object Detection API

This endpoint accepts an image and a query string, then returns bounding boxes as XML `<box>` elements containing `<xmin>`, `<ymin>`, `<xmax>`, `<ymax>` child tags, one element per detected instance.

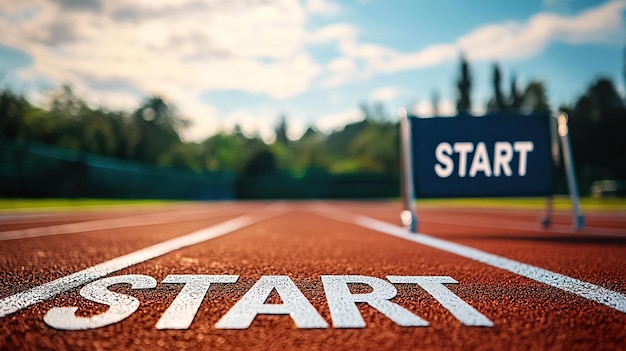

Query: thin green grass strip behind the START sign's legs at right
<box><xmin>417</xmin><ymin>196</ymin><xmax>626</xmax><ymax>212</ymax></box>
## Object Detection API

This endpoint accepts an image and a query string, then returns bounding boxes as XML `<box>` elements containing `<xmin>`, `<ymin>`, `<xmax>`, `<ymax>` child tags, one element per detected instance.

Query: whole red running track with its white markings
<box><xmin>0</xmin><ymin>201</ymin><xmax>626</xmax><ymax>350</ymax></box>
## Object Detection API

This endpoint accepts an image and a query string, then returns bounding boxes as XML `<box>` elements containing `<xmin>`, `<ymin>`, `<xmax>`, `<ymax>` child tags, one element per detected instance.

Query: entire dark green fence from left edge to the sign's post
<box><xmin>0</xmin><ymin>139</ymin><xmax>400</xmax><ymax>200</ymax></box>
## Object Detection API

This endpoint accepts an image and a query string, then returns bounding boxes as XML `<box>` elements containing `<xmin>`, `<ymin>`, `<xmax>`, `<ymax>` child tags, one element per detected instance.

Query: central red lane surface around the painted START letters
<box><xmin>2</xmin><ymin>204</ymin><xmax>626</xmax><ymax>349</ymax></box>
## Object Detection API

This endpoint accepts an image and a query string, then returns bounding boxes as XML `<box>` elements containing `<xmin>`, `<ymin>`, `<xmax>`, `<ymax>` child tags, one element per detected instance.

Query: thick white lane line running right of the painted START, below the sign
<box><xmin>315</xmin><ymin>206</ymin><xmax>626</xmax><ymax>313</ymax></box>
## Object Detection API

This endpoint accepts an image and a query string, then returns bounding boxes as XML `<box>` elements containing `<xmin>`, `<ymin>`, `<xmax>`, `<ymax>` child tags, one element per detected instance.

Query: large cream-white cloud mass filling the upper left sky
<box><xmin>0</xmin><ymin>0</ymin><xmax>338</xmax><ymax>140</ymax></box>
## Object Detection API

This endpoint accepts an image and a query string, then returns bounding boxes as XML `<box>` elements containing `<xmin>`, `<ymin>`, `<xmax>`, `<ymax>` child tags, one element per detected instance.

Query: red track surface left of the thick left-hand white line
<box><xmin>0</xmin><ymin>203</ymin><xmax>267</xmax><ymax>298</ymax></box>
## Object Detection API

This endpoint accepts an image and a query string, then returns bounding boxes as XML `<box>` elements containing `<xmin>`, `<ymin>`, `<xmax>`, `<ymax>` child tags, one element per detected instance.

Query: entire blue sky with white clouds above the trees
<box><xmin>0</xmin><ymin>0</ymin><xmax>626</xmax><ymax>142</ymax></box>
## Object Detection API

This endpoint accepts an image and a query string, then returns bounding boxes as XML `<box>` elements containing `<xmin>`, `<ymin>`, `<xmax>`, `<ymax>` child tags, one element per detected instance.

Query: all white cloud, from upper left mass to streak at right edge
<box><xmin>0</xmin><ymin>0</ymin><xmax>626</xmax><ymax>139</ymax></box>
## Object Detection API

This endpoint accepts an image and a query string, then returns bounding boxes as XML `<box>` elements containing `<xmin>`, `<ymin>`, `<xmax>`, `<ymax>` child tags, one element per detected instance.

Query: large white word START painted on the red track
<box><xmin>44</xmin><ymin>274</ymin><xmax>493</xmax><ymax>330</ymax></box>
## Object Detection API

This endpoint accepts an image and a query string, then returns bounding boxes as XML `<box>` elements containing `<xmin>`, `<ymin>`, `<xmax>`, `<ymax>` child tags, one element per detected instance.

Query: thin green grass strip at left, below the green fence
<box><xmin>0</xmin><ymin>199</ymin><xmax>176</xmax><ymax>211</ymax></box>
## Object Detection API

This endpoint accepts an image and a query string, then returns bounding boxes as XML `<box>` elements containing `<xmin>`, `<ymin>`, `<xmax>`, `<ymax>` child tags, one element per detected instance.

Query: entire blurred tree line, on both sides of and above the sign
<box><xmin>0</xmin><ymin>57</ymin><xmax>626</xmax><ymax>195</ymax></box>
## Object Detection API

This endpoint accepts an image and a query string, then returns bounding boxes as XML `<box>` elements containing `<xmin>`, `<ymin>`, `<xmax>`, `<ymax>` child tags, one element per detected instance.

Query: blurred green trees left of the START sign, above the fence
<box><xmin>0</xmin><ymin>85</ymin><xmax>399</xmax><ymax>175</ymax></box>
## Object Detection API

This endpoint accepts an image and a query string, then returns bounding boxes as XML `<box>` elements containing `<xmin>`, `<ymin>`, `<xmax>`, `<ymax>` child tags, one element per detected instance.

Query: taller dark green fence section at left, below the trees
<box><xmin>0</xmin><ymin>139</ymin><xmax>235</xmax><ymax>200</ymax></box>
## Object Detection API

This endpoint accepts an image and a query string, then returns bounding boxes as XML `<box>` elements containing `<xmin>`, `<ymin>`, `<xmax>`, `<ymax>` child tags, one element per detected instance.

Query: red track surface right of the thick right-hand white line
<box><xmin>334</xmin><ymin>204</ymin><xmax>626</xmax><ymax>293</ymax></box>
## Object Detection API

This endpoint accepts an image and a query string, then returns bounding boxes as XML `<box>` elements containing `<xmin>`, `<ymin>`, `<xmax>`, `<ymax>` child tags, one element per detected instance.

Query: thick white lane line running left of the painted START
<box><xmin>0</xmin><ymin>205</ymin><xmax>285</xmax><ymax>318</ymax></box>
